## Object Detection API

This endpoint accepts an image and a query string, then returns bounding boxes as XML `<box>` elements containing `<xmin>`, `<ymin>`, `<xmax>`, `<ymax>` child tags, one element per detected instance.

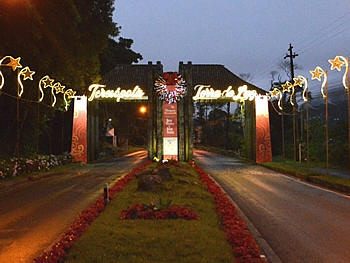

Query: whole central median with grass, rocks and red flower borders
<box><xmin>36</xmin><ymin>162</ymin><xmax>265</xmax><ymax>263</ymax></box>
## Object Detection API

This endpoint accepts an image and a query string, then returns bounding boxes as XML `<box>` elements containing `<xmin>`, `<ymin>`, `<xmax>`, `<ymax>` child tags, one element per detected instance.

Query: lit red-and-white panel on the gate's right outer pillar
<box><xmin>255</xmin><ymin>96</ymin><xmax>272</xmax><ymax>163</ymax></box>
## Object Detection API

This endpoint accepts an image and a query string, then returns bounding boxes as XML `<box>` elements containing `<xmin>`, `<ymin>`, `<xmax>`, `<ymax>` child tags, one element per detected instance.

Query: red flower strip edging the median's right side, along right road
<box><xmin>191</xmin><ymin>161</ymin><xmax>266</xmax><ymax>263</ymax></box>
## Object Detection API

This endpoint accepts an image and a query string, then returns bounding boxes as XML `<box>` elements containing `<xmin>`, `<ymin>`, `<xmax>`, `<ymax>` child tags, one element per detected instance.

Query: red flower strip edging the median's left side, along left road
<box><xmin>34</xmin><ymin>161</ymin><xmax>151</xmax><ymax>263</ymax></box>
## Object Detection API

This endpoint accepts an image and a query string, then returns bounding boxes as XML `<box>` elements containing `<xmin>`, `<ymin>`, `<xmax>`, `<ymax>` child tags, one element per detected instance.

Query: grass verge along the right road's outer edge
<box><xmin>260</xmin><ymin>162</ymin><xmax>350</xmax><ymax>194</ymax></box>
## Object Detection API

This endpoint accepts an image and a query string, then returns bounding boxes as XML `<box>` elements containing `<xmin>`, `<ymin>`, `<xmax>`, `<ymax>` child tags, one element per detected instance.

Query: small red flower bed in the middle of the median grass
<box><xmin>120</xmin><ymin>204</ymin><xmax>198</xmax><ymax>220</ymax></box>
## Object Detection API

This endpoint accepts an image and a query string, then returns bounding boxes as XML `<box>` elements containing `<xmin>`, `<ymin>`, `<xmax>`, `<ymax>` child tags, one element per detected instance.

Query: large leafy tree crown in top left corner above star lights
<box><xmin>0</xmin><ymin>0</ymin><xmax>119</xmax><ymax>91</ymax></box>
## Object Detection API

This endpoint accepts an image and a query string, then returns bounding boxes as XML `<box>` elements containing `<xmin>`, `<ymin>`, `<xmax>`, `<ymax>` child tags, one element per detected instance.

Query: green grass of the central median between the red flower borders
<box><xmin>65</xmin><ymin>164</ymin><xmax>234</xmax><ymax>263</ymax></box>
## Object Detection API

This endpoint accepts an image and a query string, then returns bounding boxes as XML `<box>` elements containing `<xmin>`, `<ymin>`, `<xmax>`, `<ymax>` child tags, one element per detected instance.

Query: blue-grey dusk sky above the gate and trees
<box><xmin>114</xmin><ymin>0</ymin><xmax>350</xmax><ymax>95</ymax></box>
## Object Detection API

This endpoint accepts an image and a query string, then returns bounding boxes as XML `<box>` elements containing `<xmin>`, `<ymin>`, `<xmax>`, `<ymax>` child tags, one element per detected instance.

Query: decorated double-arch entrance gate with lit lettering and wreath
<box><xmin>72</xmin><ymin>62</ymin><xmax>272</xmax><ymax>165</ymax></box>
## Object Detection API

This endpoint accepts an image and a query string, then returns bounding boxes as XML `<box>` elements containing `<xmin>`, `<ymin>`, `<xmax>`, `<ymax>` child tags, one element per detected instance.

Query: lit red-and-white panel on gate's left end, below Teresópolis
<box><xmin>71</xmin><ymin>96</ymin><xmax>88</xmax><ymax>163</ymax></box>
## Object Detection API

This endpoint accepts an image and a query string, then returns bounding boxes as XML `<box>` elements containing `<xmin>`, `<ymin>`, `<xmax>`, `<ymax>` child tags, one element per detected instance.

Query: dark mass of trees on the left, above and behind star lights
<box><xmin>0</xmin><ymin>0</ymin><xmax>142</xmax><ymax>159</ymax></box>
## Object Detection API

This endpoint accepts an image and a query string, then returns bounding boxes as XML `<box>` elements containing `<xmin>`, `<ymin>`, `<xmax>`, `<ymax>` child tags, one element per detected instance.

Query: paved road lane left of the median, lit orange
<box><xmin>0</xmin><ymin>151</ymin><xmax>147</xmax><ymax>263</ymax></box>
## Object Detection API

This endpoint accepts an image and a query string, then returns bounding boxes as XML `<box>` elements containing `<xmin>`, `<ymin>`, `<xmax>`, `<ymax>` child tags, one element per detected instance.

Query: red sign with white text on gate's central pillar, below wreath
<box><xmin>163</xmin><ymin>85</ymin><xmax>178</xmax><ymax>160</ymax></box>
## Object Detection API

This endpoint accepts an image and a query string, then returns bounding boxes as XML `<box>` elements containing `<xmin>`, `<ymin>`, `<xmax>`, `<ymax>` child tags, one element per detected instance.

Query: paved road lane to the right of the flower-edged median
<box><xmin>194</xmin><ymin>150</ymin><xmax>350</xmax><ymax>263</ymax></box>
